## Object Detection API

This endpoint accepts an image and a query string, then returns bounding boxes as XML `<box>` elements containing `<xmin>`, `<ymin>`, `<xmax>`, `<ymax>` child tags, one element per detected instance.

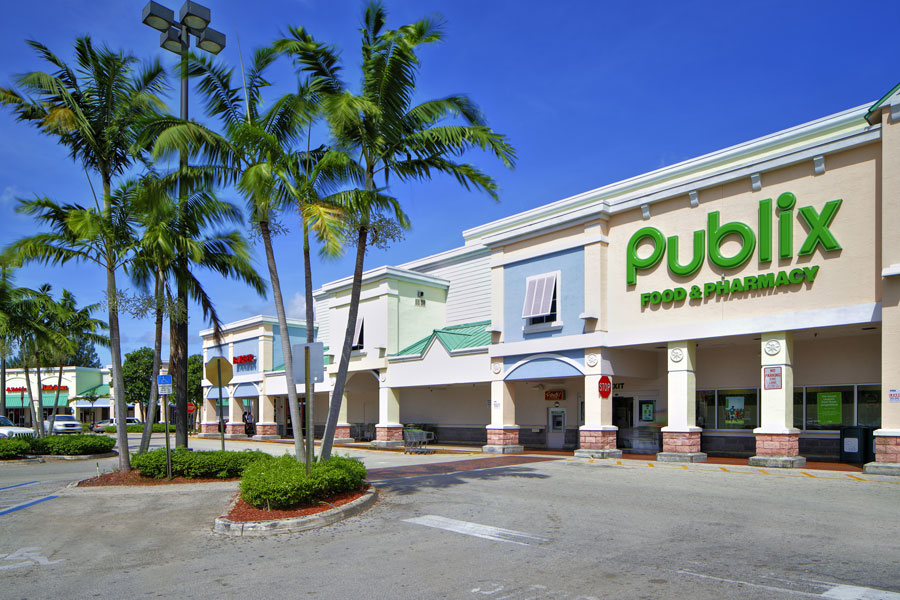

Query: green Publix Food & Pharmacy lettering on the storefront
<box><xmin>625</xmin><ymin>192</ymin><xmax>843</xmax><ymax>306</ymax></box>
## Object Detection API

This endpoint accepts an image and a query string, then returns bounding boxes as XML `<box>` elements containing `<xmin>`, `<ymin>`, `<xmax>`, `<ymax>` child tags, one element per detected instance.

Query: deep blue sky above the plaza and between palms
<box><xmin>0</xmin><ymin>0</ymin><xmax>900</xmax><ymax>363</ymax></box>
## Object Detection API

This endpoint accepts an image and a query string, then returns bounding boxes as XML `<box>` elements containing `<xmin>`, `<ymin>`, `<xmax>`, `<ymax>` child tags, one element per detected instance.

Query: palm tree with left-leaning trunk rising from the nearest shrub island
<box><xmin>145</xmin><ymin>48</ymin><xmax>326</xmax><ymax>460</ymax></box>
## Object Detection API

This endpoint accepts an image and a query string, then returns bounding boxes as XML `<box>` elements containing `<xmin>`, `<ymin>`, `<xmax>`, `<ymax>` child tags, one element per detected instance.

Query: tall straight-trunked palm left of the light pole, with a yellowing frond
<box><xmin>0</xmin><ymin>37</ymin><xmax>165</xmax><ymax>472</ymax></box>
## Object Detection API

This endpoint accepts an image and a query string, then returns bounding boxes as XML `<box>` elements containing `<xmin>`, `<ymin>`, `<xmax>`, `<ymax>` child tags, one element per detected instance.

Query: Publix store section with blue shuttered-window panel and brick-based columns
<box><xmin>474</xmin><ymin>83</ymin><xmax>900</xmax><ymax>470</ymax></box>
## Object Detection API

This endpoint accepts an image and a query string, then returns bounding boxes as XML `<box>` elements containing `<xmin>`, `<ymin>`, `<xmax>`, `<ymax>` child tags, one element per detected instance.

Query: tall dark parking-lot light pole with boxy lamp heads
<box><xmin>141</xmin><ymin>0</ymin><xmax>225</xmax><ymax>446</ymax></box>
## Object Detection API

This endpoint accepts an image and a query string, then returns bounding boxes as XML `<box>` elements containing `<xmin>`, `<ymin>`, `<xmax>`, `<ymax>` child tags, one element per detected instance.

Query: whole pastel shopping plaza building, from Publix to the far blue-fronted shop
<box><xmin>201</xmin><ymin>86</ymin><xmax>900</xmax><ymax>472</ymax></box>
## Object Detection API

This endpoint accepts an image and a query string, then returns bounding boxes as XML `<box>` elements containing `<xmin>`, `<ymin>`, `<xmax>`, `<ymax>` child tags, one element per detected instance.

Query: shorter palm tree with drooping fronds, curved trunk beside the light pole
<box><xmin>130</xmin><ymin>172</ymin><xmax>266</xmax><ymax>453</ymax></box>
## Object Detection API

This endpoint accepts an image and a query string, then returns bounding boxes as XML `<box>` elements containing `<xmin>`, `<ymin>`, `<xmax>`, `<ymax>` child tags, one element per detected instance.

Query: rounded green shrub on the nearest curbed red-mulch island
<box><xmin>241</xmin><ymin>454</ymin><xmax>366</xmax><ymax>509</ymax></box>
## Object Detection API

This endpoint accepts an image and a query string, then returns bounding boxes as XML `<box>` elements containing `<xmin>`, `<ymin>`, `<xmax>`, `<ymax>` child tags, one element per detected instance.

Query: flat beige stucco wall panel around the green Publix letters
<box><xmin>606</xmin><ymin>144</ymin><xmax>880</xmax><ymax>331</ymax></box>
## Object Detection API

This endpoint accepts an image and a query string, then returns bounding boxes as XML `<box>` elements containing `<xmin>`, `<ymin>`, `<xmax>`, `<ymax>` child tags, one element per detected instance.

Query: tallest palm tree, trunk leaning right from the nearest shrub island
<box><xmin>276</xmin><ymin>2</ymin><xmax>515</xmax><ymax>459</ymax></box>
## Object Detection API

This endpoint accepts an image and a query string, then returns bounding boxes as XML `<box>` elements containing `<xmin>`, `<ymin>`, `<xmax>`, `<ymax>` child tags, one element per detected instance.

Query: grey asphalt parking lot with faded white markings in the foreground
<box><xmin>0</xmin><ymin>441</ymin><xmax>900</xmax><ymax>600</ymax></box>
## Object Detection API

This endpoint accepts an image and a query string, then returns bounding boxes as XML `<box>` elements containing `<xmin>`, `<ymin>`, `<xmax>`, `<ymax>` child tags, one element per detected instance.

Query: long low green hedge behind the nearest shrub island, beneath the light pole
<box><xmin>131</xmin><ymin>448</ymin><xmax>272</xmax><ymax>479</ymax></box>
